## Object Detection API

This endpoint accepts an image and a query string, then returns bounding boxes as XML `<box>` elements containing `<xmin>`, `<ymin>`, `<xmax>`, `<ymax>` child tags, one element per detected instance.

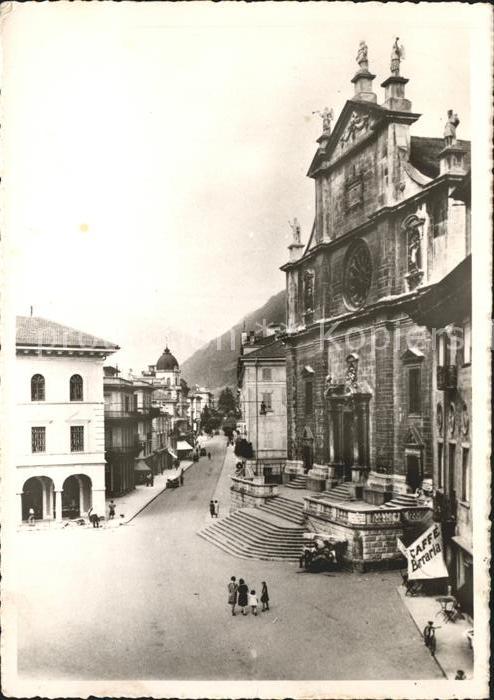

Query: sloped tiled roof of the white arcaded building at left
<box><xmin>16</xmin><ymin>316</ymin><xmax>119</xmax><ymax>351</ymax></box>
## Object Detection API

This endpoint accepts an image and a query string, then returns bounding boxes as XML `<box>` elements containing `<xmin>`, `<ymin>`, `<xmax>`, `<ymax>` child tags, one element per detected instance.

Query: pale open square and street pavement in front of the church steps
<box><xmin>18</xmin><ymin>436</ymin><xmax>441</xmax><ymax>680</ymax></box>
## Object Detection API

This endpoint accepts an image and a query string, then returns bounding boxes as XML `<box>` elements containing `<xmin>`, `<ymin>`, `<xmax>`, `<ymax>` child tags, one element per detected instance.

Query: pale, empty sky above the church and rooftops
<box><xmin>2</xmin><ymin>3</ymin><xmax>489</xmax><ymax>370</ymax></box>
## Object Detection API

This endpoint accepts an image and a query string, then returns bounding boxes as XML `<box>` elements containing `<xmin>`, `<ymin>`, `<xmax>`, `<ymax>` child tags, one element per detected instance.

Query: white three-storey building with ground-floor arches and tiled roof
<box><xmin>14</xmin><ymin>316</ymin><xmax>118</xmax><ymax>520</ymax></box>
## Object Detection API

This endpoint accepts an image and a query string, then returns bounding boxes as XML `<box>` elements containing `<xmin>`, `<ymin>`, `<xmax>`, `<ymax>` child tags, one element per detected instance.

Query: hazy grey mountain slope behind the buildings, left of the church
<box><xmin>181</xmin><ymin>289</ymin><xmax>286</xmax><ymax>390</ymax></box>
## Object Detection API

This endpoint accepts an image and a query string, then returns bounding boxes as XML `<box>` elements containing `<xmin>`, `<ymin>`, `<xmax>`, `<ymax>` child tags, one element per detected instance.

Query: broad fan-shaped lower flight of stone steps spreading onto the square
<box><xmin>198</xmin><ymin>506</ymin><xmax>304</xmax><ymax>561</ymax></box>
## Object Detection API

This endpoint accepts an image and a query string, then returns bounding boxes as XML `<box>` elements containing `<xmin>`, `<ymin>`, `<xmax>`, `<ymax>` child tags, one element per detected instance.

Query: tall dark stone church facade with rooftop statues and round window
<box><xmin>281</xmin><ymin>42</ymin><xmax>470</xmax><ymax>506</ymax></box>
